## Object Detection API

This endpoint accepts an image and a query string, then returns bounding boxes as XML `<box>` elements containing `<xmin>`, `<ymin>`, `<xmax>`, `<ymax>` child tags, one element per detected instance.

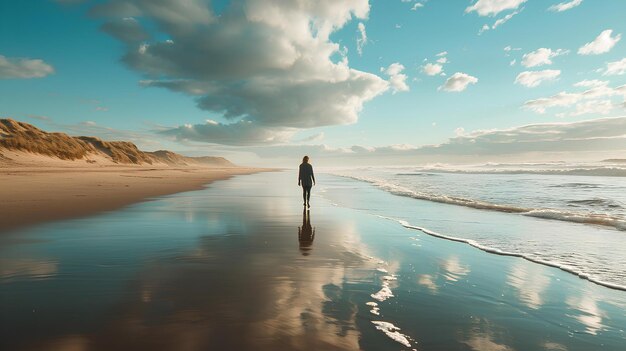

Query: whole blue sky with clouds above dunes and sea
<box><xmin>0</xmin><ymin>0</ymin><xmax>626</xmax><ymax>165</ymax></box>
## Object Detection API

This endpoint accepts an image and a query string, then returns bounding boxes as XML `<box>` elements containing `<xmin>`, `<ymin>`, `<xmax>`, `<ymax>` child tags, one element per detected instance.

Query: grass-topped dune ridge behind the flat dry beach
<box><xmin>0</xmin><ymin>119</ymin><xmax>236</xmax><ymax>167</ymax></box>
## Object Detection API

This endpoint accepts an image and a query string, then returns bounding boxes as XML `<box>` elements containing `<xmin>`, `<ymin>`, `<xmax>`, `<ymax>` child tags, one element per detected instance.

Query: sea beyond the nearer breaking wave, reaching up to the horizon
<box><xmin>334</xmin><ymin>163</ymin><xmax>626</xmax><ymax>231</ymax></box>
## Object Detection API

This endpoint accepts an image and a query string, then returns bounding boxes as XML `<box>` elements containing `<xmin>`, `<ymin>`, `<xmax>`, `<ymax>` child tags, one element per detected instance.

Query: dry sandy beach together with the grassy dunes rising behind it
<box><xmin>0</xmin><ymin>119</ymin><xmax>263</xmax><ymax>232</ymax></box>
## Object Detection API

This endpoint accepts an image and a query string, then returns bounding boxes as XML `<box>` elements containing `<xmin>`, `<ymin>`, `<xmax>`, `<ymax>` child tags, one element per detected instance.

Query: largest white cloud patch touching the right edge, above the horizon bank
<box><xmin>523</xmin><ymin>81</ymin><xmax>626</xmax><ymax>116</ymax></box>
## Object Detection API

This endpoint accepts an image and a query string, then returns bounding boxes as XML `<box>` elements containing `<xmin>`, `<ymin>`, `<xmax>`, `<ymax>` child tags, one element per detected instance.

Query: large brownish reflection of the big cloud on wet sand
<box><xmin>20</xmin><ymin>210</ymin><xmax>380</xmax><ymax>350</ymax></box>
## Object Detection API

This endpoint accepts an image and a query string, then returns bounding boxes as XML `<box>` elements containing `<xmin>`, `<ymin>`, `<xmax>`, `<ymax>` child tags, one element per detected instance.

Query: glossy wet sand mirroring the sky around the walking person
<box><xmin>0</xmin><ymin>172</ymin><xmax>626</xmax><ymax>350</ymax></box>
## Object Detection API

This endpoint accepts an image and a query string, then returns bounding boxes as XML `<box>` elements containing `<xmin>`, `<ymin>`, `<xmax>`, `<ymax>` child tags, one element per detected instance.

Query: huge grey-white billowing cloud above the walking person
<box><xmin>91</xmin><ymin>0</ymin><xmax>388</xmax><ymax>145</ymax></box>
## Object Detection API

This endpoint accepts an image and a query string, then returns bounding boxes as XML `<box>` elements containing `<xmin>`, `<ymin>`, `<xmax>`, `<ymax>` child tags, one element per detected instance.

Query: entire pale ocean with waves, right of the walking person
<box><xmin>329</xmin><ymin>161</ymin><xmax>626</xmax><ymax>290</ymax></box>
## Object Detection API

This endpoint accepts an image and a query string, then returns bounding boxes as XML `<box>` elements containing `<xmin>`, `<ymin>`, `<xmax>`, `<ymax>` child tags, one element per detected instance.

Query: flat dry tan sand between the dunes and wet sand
<box><xmin>0</xmin><ymin>166</ymin><xmax>276</xmax><ymax>233</ymax></box>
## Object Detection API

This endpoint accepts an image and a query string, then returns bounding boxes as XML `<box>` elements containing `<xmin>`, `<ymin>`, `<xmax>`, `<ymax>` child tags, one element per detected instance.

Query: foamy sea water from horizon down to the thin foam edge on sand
<box><xmin>337</xmin><ymin>165</ymin><xmax>626</xmax><ymax>290</ymax></box>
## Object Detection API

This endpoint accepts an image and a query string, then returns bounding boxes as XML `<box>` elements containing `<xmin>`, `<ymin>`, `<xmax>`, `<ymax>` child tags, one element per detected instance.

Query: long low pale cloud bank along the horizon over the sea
<box><xmin>250</xmin><ymin>117</ymin><xmax>626</xmax><ymax>165</ymax></box>
